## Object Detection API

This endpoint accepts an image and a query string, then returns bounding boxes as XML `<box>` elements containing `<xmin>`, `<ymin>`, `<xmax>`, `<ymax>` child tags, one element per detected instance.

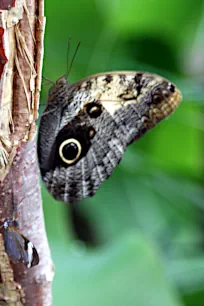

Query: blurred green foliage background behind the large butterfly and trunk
<box><xmin>41</xmin><ymin>0</ymin><xmax>204</xmax><ymax>306</ymax></box>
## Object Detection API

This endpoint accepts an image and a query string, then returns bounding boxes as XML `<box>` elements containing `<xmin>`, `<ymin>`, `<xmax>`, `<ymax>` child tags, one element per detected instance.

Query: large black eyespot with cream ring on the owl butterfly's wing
<box><xmin>59</xmin><ymin>138</ymin><xmax>82</xmax><ymax>165</ymax></box>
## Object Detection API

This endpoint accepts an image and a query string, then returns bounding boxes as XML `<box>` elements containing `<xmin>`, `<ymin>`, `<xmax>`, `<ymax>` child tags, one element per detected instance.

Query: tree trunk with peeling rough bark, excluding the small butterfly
<box><xmin>0</xmin><ymin>0</ymin><xmax>54</xmax><ymax>306</ymax></box>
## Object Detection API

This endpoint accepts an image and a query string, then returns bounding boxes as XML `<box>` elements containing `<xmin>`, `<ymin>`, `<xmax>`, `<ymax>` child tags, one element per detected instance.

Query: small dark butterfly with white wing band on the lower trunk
<box><xmin>1</xmin><ymin>220</ymin><xmax>39</xmax><ymax>268</ymax></box>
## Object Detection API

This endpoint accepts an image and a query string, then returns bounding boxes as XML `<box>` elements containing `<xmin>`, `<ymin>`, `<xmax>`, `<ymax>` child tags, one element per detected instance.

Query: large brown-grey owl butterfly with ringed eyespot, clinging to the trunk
<box><xmin>38</xmin><ymin>71</ymin><xmax>181</xmax><ymax>202</ymax></box>
